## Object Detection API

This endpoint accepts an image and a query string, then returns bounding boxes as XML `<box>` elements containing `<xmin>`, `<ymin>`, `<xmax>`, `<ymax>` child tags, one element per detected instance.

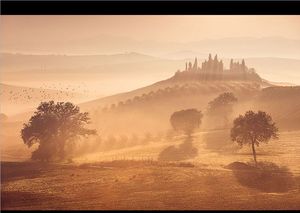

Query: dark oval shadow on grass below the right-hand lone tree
<box><xmin>226</xmin><ymin>162</ymin><xmax>297</xmax><ymax>193</ymax></box>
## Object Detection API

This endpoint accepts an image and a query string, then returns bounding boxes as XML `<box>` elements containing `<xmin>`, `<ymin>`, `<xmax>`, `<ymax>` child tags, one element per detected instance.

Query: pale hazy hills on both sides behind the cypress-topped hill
<box><xmin>0</xmin><ymin>52</ymin><xmax>300</xmax><ymax>97</ymax></box>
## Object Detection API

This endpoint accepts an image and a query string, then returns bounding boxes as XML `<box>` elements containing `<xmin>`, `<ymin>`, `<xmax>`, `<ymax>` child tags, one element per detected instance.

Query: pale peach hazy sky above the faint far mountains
<box><xmin>1</xmin><ymin>15</ymin><xmax>300</xmax><ymax>43</ymax></box>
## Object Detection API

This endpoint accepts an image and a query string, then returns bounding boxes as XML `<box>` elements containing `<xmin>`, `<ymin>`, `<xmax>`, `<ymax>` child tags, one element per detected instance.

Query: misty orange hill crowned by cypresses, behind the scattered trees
<box><xmin>2</xmin><ymin>56</ymin><xmax>300</xmax><ymax>153</ymax></box>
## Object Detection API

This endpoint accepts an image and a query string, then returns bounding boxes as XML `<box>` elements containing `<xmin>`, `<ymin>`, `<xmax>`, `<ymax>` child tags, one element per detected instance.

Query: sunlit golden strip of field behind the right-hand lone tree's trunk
<box><xmin>74</xmin><ymin>130</ymin><xmax>300</xmax><ymax>175</ymax></box>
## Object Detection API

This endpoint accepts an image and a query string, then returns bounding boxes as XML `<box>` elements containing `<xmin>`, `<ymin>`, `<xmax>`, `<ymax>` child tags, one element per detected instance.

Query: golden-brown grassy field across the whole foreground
<box><xmin>1</xmin><ymin>131</ymin><xmax>300</xmax><ymax>210</ymax></box>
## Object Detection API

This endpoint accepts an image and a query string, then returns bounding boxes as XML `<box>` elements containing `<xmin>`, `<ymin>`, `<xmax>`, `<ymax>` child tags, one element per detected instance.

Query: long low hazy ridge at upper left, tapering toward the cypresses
<box><xmin>0</xmin><ymin>52</ymin><xmax>158</xmax><ymax>72</ymax></box>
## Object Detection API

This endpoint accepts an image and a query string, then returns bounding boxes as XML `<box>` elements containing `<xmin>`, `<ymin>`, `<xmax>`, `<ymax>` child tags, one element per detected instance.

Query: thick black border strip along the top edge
<box><xmin>1</xmin><ymin>0</ymin><xmax>300</xmax><ymax>15</ymax></box>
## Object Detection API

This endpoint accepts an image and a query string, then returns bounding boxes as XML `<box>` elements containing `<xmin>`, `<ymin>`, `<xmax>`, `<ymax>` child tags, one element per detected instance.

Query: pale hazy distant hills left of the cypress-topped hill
<box><xmin>0</xmin><ymin>53</ymin><xmax>183</xmax><ymax>97</ymax></box>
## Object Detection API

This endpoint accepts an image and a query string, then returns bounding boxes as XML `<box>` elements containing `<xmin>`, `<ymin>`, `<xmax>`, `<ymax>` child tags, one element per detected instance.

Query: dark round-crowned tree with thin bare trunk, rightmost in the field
<box><xmin>231</xmin><ymin>111</ymin><xmax>278</xmax><ymax>165</ymax></box>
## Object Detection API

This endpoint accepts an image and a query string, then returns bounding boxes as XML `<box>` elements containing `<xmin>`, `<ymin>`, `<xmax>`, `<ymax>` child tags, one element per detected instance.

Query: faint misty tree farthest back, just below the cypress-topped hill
<box><xmin>208</xmin><ymin>92</ymin><xmax>237</xmax><ymax>126</ymax></box>
